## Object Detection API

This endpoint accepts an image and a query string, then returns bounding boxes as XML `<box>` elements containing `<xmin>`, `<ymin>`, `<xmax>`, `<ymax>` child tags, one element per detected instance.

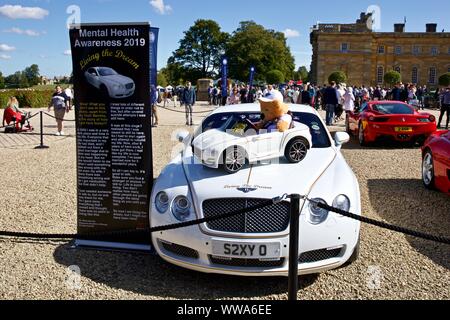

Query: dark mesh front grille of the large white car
<box><xmin>203</xmin><ymin>198</ymin><xmax>290</xmax><ymax>233</ymax></box>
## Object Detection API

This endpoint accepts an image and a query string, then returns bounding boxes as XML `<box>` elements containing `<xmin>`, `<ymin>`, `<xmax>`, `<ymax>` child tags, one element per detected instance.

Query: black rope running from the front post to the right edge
<box><xmin>307</xmin><ymin>199</ymin><xmax>450</xmax><ymax>244</ymax></box>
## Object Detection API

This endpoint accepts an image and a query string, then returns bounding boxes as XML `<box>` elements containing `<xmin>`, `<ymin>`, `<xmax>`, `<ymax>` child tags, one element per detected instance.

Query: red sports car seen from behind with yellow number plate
<box><xmin>346</xmin><ymin>101</ymin><xmax>437</xmax><ymax>146</ymax></box>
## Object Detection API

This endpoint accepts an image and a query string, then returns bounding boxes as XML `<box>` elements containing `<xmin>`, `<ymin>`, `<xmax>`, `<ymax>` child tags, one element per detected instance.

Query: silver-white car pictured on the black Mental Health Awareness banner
<box><xmin>85</xmin><ymin>67</ymin><xmax>136</xmax><ymax>99</ymax></box>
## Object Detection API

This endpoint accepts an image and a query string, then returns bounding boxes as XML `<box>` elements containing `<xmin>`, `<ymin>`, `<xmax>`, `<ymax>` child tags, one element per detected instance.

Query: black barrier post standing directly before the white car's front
<box><xmin>288</xmin><ymin>194</ymin><xmax>301</xmax><ymax>301</ymax></box>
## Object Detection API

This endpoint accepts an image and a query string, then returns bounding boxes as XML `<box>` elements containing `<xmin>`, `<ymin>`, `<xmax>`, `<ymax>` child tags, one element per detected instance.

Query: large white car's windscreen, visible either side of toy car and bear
<box><xmin>195</xmin><ymin>112</ymin><xmax>331</xmax><ymax>148</ymax></box>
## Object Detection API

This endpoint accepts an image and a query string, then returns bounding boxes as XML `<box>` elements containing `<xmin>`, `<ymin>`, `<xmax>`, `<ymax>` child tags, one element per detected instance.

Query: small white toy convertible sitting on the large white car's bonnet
<box><xmin>192</xmin><ymin>114</ymin><xmax>312</xmax><ymax>174</ymax></box>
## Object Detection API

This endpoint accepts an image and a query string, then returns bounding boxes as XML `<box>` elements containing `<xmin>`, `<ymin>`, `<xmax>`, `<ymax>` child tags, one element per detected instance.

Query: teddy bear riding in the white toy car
<box><xmin>256</xmin><ymin>91</ymin><xmax>293</xmax><ymax>132</ymax></box>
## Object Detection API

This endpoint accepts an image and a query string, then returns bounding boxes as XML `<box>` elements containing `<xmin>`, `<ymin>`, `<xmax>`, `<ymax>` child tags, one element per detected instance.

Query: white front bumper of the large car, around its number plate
<box><xmin>152</xmin><ymin>205</ymin><xmax>360</xmax><ymax>276</ymax></box>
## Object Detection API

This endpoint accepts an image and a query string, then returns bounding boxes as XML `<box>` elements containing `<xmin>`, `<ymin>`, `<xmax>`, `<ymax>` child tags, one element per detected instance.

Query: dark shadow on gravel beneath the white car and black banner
<box><xmin>53</xmin><ymin>245</ymin><xmax>318</xmax><ymax>300</ymax></box>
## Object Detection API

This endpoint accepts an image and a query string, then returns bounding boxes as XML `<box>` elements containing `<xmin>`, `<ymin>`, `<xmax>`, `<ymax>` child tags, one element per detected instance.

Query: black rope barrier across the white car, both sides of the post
<box><xmin>0</xmin><ymin>194</ymin><xmax>450</xmax><ymax>244</ymax></box>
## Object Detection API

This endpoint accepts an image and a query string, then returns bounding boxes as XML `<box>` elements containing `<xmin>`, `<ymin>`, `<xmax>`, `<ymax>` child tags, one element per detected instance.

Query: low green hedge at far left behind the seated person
<box><xmin>0</xmin><ymin>90</ymin><xmax>54</xmax><ymax>109</ymax></box>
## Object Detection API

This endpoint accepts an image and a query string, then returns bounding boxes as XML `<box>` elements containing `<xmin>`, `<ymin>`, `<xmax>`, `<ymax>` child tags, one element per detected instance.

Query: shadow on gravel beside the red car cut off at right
<box><xmin>368</xmin><ymin>179</ymin><xmax>450</xmax><ymax>269</ymax></box>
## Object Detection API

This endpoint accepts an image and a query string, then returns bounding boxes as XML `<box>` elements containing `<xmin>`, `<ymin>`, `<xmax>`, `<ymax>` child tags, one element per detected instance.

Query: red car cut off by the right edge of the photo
<box><xmin>422</xmin><ymin>131</ymin><xmax>450</xmax><ymax>195</ymax></box>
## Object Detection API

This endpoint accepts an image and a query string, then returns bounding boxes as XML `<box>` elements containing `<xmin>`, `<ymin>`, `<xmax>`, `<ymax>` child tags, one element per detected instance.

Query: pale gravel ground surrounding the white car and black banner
<box><xmin>0</xmin><ymin>106</ymin><xmax>450</xmax><ymax>300</ymax></box>
